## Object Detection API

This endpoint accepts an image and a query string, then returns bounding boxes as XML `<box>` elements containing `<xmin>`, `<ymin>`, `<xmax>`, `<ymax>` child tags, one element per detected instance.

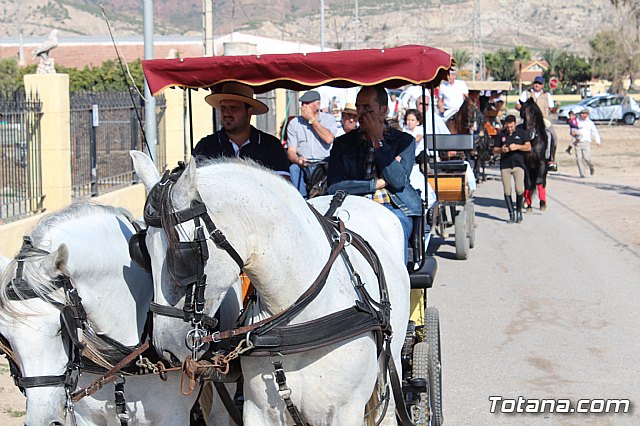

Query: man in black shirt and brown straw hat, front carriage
<box><xmin>193</xmin><ymin>82</ymin><xmax>289</xmax><ymax>179</ymax></box>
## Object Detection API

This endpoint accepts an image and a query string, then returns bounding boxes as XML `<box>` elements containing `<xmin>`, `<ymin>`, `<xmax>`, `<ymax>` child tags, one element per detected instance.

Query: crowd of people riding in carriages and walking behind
<box><xmin>193</xmin><ymin>72</ymin><xmax>600</xmax><ymax>243</ymax></box>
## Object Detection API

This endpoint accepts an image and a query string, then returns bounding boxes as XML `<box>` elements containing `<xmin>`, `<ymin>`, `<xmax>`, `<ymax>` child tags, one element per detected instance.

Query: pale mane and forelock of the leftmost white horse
<box><xmin>0</xmin><ymin>203</ymin><xmax>134</xmax><ymax>317</ymax></box>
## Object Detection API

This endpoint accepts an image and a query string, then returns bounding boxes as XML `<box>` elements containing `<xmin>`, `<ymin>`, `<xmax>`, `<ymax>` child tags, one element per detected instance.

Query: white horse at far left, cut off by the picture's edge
<box><xmin>0</xmin><ymin>204</ymin><xmax>204</xmax><ymax>425</ymax></box>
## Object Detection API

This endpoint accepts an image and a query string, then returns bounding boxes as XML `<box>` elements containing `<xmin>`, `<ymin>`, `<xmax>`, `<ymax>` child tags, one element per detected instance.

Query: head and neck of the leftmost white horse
<box><xmin>0</xmin><ymin>204</ymin><xmax>153</xmax><ymax>425</ymax></box>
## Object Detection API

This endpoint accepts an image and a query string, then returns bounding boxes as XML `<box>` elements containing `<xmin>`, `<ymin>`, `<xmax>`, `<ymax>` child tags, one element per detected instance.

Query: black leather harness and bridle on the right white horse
<box><xmin>130</xmin><ymin>164</ymin><xmax>413</xmax><ymax>426</ymax></box>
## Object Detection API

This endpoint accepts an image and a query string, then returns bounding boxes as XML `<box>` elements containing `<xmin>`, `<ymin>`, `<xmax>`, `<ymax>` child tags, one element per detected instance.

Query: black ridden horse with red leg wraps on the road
<box><xmin>520</xmin><ymin>99</ymin><xmax>549</xmax><ymax>213</ymax></box>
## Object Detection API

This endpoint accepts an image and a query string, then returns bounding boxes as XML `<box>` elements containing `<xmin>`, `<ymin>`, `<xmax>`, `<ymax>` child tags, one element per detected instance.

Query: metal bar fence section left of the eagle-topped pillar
<box><xmin>0</xmin><ymin>89</ymin><xmax>43</xmax><ymax>223</ymax></box>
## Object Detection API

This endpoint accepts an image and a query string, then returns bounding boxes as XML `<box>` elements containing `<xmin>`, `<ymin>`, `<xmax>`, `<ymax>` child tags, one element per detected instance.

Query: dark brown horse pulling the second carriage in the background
<box><xmin>445</xmin><ymin>97</ymin><xmax>490</xmax><ymax>181</ymax></box>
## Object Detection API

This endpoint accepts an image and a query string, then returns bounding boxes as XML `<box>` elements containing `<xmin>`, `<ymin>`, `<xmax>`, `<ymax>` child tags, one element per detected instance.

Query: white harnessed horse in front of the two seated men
<box><xmin>131</xmin><ymin>151</ymin><xmax>409</xmax><ymax>425</ymax></box>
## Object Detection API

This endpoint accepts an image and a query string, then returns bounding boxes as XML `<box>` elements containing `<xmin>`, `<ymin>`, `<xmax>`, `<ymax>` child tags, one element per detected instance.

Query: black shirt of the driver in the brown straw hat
<box><xmin>192</xmin><ymin>126</ymin><xmax>289</xmax><ymax>176</ymax></box>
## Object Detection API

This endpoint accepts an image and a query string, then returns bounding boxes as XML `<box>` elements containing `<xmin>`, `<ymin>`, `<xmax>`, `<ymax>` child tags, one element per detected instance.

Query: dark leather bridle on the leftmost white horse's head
<box><xmin>0</xmin><ymin>236</ymin><xmax>87</xmax><ymax>413</ymax></box>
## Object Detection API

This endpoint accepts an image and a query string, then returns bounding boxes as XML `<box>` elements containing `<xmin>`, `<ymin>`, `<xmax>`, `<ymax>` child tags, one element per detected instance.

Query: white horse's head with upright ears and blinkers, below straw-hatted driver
<box><xmin>131</xmin><ymin>151</ymin><xmax>246</xmax><ymax>364</ymax></box>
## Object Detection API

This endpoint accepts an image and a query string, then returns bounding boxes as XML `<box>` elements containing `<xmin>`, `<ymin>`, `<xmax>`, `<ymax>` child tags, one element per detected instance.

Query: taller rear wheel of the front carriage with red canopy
<box><xmin>425</xmin><ymin>306</ymin><xmax>443</xmax><ymax>426</ymax></box>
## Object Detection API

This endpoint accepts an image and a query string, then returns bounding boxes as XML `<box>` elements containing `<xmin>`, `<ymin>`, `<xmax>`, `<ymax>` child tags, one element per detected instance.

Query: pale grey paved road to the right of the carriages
<box><xmin>429</xmin><ymin>171</ymin><xmax>640</xmax><ymax>425</ymax></box>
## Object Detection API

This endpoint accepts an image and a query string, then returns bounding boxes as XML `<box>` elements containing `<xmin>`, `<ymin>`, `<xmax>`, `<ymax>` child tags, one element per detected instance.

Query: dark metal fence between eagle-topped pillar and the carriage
<box><xmin>70</xmin><ymin>92</ymin><xmax>166</xmax><ymax>198</ymax></box>
